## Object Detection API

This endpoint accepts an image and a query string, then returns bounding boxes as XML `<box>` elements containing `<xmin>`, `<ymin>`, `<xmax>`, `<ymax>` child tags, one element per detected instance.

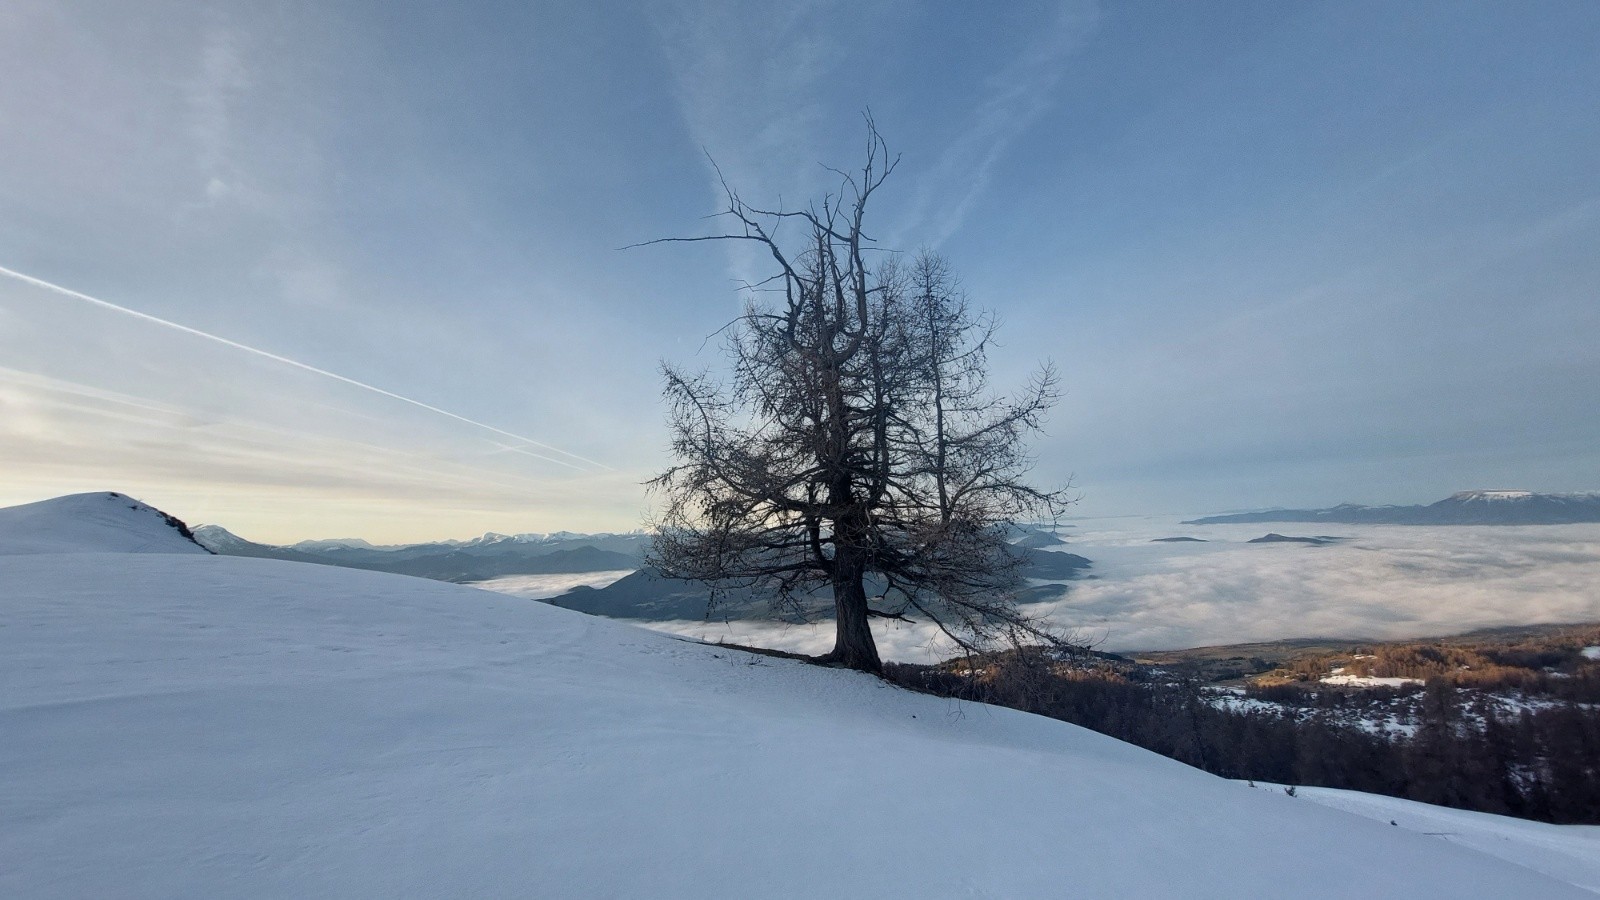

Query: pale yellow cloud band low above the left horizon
<box><xmin>0</xmin><ymin>368</ymin><xmax>640</xmax><ymax>540</ymax></box>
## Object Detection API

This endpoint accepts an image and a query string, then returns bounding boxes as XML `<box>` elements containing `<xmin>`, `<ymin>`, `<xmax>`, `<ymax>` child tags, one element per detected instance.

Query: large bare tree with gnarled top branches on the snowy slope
<box><xmin>650</xmin><ymin>119</ymin><xmax>1069</xmax><ymax>671</ymax></box>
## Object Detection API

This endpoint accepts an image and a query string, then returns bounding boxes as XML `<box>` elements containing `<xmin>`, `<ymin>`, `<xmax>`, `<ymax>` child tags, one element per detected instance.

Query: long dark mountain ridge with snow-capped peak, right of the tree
<box><xmin>1184</xmin><ymin>490</ymin><xmax>1600</xmax><ymax>525</ymax></box>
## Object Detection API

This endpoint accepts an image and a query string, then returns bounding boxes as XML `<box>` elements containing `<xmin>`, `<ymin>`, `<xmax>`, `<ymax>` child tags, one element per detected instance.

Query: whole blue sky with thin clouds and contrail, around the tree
<box><xmin>0</xmin><ymin>0</ymin><xmax>1600</xmax><ymax>540</ymax></box>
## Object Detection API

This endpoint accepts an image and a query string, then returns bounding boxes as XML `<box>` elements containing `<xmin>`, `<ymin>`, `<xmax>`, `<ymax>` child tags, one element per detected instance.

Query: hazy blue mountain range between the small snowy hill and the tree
<box><xmin>194</xmin><ymin>525</ymin><xmax>650</xmax><ymax>583</ymax></box>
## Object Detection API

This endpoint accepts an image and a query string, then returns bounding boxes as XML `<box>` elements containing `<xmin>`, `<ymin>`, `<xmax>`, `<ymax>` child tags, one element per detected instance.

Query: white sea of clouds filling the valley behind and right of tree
<box><xmin>630</xmin><ymin>517</ymin><xmax>1600</xmax><ymax>661</ymax></box>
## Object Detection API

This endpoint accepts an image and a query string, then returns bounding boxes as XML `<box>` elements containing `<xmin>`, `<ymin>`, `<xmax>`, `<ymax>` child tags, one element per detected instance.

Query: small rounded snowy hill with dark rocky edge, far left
<box><xmin>0</xmin><ymin>492</ymin><xmax>210</xmax><ymax>556</ymax></box>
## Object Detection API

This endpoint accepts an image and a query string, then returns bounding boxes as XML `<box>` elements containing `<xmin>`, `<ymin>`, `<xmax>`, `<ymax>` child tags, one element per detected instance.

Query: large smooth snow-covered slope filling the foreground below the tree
<box><xmin>0</xmin><ymin>554</ymin><xmax>1587</xmax><ymax>898</ymax></box>
